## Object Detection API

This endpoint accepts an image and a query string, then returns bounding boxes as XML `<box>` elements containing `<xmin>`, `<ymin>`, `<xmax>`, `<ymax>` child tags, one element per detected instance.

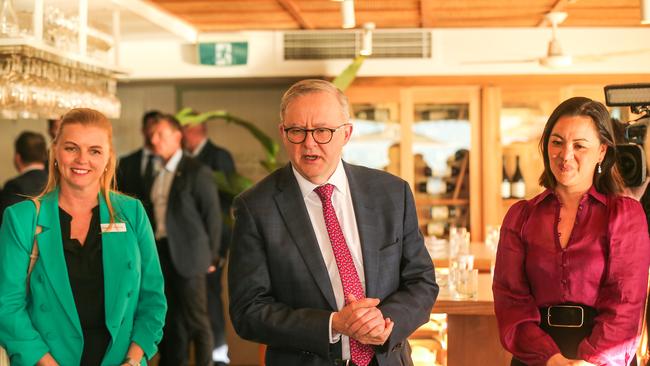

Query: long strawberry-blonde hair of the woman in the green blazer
<box><xmin>36</xmin><ymin>108</ymin><xmax>117</xmax><ymax>224</ymax></box>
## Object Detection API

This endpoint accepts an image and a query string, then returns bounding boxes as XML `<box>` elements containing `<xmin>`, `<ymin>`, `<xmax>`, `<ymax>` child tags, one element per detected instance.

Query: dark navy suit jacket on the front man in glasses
<box><xmin>228</xmin><ymin>163</ymin><xmax>438</xmax><ymax>366</ymax></box>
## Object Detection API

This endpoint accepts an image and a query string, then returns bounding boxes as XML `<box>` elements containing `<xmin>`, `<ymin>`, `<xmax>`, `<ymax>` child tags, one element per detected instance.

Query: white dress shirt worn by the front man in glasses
<box><xmin>292</xmin><ymin>161</ymin><xmax>366</xmax><ymax>360</ymax></box>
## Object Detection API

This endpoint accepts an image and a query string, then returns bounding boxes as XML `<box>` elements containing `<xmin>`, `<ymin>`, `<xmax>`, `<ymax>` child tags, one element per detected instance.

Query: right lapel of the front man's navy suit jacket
<box><xmin>343</xmin><ymin>162</ymin><xmax>385</xmax><ymax>297</ymax></box>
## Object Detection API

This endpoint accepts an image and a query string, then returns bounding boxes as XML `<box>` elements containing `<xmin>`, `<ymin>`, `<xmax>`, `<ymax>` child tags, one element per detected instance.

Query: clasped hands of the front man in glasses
<box><xmin>332</xmin><ymin>294</ymin><xmax>395</xmax><ymax>346</ymax></box>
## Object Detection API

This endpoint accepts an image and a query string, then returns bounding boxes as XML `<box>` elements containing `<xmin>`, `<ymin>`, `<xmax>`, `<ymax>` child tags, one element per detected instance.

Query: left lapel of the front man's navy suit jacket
<box><xmin>274</xmin><ymin>165</ymin><xmax>337</xmax><ymax>310</ymax></box>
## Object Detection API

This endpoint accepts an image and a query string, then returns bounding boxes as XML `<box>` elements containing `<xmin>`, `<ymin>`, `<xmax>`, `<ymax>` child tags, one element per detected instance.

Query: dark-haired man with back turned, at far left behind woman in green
<box><xmin>0</xmin><ymin>131</ymin><xmax>47</xmax><ymax>223</ymax></box>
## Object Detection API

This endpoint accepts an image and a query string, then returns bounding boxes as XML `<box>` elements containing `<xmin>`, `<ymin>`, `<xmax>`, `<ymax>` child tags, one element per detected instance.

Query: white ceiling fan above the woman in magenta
<box><xmin>462</xmin><ymin>11</ymin><xmax>650</xmax><ymax>68</ymax></box>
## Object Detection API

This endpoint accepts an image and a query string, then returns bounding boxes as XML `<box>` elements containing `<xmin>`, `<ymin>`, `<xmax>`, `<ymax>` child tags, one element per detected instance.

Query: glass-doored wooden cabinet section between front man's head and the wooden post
<box><xmin>343</xmin><ymin>86</ymin><xmax>482</xmax><ymax>240</ymax></box>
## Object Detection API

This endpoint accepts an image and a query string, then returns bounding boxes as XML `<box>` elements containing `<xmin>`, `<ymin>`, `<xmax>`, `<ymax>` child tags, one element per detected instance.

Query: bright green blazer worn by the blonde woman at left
<box><xmin>0</xmin><ymin>190</ymin><xmax>167</xmax><ymax>366</ymax></box>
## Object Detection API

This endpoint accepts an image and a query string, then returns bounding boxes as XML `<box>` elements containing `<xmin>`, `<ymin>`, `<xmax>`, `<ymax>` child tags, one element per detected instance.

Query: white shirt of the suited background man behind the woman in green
<box><xmin>151</xmin><ymin>149</ymin><xmax>183</xmax><ymax>240</ymax></box>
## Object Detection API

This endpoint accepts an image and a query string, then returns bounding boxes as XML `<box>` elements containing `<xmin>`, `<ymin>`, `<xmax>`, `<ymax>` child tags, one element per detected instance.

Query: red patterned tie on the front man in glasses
<box><xmin>314</xmin><ymin>183</ymin><xmax>375</xmax><ymax>366</ymax></box>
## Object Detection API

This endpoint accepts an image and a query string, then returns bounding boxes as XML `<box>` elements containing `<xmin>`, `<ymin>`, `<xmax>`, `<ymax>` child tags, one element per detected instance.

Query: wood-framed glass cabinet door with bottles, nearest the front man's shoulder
<box><xmin>402</xmin><ymin>87</ymin><xmax>482</xmax><ymax>240</ymax></box>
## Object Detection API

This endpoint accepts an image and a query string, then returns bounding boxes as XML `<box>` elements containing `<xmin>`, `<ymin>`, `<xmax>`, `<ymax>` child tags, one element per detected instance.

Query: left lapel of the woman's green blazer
<box><xmin>37</xmin><ymin>189</ymin><xmax>82</xmax><ymax>335</ymax></box>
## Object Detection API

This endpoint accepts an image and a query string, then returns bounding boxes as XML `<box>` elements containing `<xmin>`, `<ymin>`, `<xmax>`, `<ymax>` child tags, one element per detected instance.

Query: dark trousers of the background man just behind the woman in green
<box><xmin>156</xmin><ymin>239</ymin><xmax>212</xmax><ymax>366</ymax></box>
